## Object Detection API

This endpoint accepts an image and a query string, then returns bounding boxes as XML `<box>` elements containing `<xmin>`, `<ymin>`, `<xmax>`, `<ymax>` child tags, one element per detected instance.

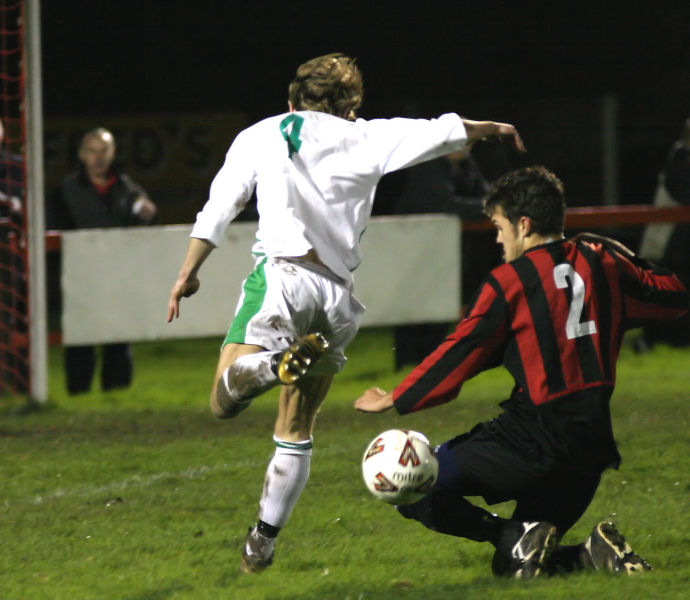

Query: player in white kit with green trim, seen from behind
<box><xmin>167</xmin><ymin>54</ymin><xmax>524</xmax><ymax>572</ymax></box>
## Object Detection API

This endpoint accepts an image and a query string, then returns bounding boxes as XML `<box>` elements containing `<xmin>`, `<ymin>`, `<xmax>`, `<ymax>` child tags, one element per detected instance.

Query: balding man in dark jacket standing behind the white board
<box><xmin>46</xmin><ymin>128</ymin><xmax>157</xmax><ymax>394</ymax></box>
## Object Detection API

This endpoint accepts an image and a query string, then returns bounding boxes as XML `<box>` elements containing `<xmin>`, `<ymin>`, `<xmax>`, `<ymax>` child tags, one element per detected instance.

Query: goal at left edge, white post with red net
<box><xmin>0</xmin><ymin>0</ymin><xmax>47</xmax><ymax>402</ymax></box>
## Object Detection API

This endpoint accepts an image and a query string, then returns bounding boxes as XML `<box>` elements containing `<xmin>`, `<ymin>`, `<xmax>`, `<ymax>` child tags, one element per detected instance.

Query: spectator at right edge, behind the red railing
<box><xmin>635</xmin><ymin>118</ymin><xmax>690</xmax><ymax>352</ymax></box>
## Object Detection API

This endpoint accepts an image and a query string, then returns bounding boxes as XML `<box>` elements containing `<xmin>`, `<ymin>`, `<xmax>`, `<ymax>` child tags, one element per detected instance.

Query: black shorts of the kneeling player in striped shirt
<box><xmin>432</xmin><ymin>421</ymin><xmax>601</xmax><ymax>535</ymax></box>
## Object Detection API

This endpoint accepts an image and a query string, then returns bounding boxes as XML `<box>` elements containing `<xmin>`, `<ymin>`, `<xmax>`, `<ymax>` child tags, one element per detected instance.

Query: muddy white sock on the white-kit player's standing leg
<box><xmin>259</xmin><ymin>436</ymin><xmax>312</xmax><ymax>527</ymax></box>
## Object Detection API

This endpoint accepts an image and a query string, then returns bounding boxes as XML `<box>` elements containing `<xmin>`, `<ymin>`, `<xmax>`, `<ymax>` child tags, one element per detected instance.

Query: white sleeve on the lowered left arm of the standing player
<box><xmin>191</xmin><ymin>133</ymin><xmax>256</xmax><ymax>246</ymax></box>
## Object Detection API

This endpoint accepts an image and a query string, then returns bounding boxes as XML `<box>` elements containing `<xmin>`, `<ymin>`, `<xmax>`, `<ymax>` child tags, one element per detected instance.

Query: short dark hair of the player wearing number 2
<box><xmin>483</xmin><ymin>166</ymin><xmax>565</xmax><ymax>235</ymax></box>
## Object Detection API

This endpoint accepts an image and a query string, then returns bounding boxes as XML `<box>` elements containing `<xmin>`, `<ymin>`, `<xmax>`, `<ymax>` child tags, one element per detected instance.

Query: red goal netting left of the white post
<box><xmin>0</xmin><ymin>0</ymin><xmax>30</xmax><ymax>394</ymax></box>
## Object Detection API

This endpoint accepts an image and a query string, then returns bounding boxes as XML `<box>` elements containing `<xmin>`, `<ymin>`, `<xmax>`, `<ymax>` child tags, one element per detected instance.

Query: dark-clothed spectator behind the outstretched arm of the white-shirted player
<box><xmin>394</xmin><ymin>147</ymin><xmax>498</xmax><ymax>370</ymax></box>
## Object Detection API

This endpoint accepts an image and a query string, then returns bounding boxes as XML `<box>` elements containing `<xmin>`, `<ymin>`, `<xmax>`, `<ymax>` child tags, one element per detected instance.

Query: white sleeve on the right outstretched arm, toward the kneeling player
<box><xmin>365</xmin><ymin>113</ymin><xmax>467</xmax><ymax>175</ymax></box>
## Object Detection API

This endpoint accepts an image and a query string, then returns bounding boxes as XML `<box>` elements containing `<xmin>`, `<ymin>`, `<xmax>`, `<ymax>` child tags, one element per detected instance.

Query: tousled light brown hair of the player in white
<box><xmin>288</xmin><ymin>52</ymin><xmax>364</xmax><ymax>119</ymax></box>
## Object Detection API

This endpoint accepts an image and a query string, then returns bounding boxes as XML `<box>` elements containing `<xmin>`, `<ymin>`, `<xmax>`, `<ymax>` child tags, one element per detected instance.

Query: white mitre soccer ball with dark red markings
<box><xmin>362</xmin><ymin>429</ymin><xmax>438</xmax><ymax>504</ymax></box>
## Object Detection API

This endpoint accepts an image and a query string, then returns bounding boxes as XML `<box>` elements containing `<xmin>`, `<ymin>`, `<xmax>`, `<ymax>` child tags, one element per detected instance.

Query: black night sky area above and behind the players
<box><xmin>42</xmin><ymin>0</ymin><xmax>690</xmax><ymax>218</ymax></box>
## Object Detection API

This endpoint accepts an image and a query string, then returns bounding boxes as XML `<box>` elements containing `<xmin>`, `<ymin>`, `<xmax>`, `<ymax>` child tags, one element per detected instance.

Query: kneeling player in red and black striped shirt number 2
<box><xmin>355</xmin><ymin>167</ymin><xmax>688</xmax><ymax>578</ymax></box>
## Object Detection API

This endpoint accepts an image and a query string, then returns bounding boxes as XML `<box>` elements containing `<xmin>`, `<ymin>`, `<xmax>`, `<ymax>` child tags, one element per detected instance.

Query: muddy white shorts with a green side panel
<box><xmin>223</xmin><ymin>258</ymin><xmax>365</xmax><ymax>375</ymax></box>
